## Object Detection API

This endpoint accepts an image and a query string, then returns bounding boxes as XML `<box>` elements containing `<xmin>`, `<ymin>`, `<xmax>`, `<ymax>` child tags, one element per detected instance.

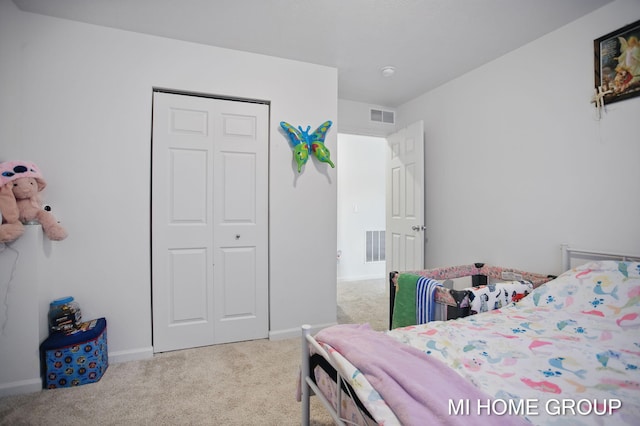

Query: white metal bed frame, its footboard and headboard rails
<box><xmin>300</xmin><ymin>244</ymin><xmax>640</xmax><ymax>426</ymax></box>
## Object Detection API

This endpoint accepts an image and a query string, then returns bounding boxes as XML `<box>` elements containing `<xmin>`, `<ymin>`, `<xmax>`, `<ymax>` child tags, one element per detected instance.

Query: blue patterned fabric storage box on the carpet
<box><xmin>40</xmin><ymin>318</ymin><xmax>109</xmax><ymax>389</ymax></box>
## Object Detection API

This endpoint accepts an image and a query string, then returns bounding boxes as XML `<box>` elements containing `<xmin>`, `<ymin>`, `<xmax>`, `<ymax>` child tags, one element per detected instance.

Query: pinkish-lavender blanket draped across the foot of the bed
<box><xmin>315</xmin><ymin>324</ymin><xmax>529</xmax><ymax>426</ymax></box>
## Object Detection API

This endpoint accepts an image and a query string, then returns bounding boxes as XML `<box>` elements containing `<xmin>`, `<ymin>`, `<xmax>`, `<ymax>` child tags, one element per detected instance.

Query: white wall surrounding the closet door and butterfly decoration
<box><xmin>0</xmin><ymin>0</ymin><xmax>337</xmax><ymax>372</ymax></box>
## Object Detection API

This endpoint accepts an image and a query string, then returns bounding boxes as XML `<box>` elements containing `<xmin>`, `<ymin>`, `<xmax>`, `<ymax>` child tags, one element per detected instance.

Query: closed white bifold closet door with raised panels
<box><xmin>151</xmin><ymin>92</ymin><xmax>269</xmax><ymax>352</ymax></box>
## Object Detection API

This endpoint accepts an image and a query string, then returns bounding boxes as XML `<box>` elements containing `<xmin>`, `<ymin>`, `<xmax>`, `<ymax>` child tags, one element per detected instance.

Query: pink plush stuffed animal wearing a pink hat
<box><xmin>0</xmin><ymin>161</ymin><xmax>67</xmax><ymax>241</ymax></box>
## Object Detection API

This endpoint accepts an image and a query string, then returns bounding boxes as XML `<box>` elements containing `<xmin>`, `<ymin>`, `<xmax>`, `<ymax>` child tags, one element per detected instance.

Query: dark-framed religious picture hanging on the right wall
<box><xmin>593</xmin><ymin>21</ymin><xmax>640</xmax><ymax>103</ymax></box>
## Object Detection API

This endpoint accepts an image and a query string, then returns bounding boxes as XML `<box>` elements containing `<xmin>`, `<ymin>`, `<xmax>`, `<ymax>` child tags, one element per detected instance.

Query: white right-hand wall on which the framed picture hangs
<box><xmin>398</xmin><ymin>0</ymin><xmax>640</xmax><ymax>273</ymax></box>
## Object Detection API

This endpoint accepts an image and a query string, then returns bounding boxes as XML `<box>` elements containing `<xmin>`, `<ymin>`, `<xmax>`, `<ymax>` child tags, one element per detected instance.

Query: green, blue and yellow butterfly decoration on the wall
<box><xmin>280</xmin><ymin>120</ymin><xmax>335</xmax><ymax>173</ymax></box>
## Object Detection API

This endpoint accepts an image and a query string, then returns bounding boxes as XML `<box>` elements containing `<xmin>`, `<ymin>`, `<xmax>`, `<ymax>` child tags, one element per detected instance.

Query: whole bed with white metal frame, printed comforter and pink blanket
<box><xmin>299</xmin><ymin>246</ymin><xmax>640</xmax><ymax>425</ymax></box>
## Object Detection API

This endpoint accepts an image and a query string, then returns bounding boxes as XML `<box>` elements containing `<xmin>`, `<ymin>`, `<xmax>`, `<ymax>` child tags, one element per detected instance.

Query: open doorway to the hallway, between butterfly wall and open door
<box><xmin>337</xmin><ymin>133</ymin><xmax>387</xmax><ymax>330</ymax></box>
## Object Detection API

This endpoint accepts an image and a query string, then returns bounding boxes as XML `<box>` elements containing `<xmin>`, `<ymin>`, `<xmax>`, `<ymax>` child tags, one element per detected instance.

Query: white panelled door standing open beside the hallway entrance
<box><xmin>386</xmin><ymin>121</ymin><xmax>425</xmax><ymax>276</ymax></box>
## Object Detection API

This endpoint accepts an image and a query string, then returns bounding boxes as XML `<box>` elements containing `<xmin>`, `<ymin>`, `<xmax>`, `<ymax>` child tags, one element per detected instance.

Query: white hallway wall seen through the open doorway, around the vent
<box><xmin>338</xmin><ymin>133</ymin><xmax>387</xmax><ymax>281</ymax></box>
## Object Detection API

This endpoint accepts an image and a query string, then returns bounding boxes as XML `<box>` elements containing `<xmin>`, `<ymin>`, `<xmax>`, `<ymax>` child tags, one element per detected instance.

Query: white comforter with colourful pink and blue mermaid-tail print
<box><xmin>318</xmin><ymin>261</ymin><xmax>640</xmax><ymax>425</ymax></box>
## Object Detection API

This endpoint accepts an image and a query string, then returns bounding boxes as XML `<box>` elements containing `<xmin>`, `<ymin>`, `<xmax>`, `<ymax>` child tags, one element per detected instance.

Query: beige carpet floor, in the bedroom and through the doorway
<box><xmin>0</xmin><ymin>279</ymin><xmax>389</xmax><ymax>426</ymax></box>
